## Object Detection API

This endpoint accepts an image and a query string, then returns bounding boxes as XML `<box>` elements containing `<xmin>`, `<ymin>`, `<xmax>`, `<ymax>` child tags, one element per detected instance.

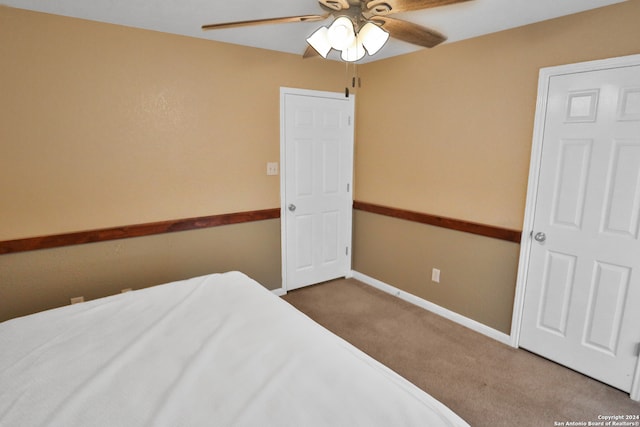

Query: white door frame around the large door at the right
<box><xmin>510</xmin><ymin>55</ymin><xmax>640</xmax><ymax>400</ymax></box>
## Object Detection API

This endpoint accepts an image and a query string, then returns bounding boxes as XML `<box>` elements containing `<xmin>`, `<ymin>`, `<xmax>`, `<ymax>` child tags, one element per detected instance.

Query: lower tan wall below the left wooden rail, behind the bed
<box><xmin>0</xmin><ymin>219</ymin><xmax>282</xmax><ymax>322</ymax></box>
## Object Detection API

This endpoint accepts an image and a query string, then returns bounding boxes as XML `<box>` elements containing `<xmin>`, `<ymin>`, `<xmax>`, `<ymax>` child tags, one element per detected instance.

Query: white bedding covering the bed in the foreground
<box><xmin>0</xmin><ymin>272</ymin><xmax>467</xmax><ymax>427</ymax></box>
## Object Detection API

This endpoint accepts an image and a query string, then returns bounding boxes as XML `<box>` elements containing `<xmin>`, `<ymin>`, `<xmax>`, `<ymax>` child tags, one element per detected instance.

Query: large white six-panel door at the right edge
<box><xmin>519</xmin><ymin>57</ymin><xmax>640</xmax><ymax>392</ymax></box>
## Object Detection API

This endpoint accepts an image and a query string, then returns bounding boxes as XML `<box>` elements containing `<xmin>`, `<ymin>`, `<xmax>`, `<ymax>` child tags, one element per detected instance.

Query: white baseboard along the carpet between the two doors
<box><xmin>351</xmin><ymin>271</ymin><xmax>513</xmax><ymax>346</ymax></box>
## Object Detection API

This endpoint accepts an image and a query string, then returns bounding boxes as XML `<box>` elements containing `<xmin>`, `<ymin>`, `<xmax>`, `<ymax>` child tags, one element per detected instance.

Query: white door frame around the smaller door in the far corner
<box><xmin>280</xmin><ymin>87</ymin><xmax>355</xmax><ymax>293</ymax></box>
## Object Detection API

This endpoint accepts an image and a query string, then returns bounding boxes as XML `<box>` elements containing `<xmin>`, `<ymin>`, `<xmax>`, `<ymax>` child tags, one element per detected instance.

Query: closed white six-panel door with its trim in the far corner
<box><xmin>281</xmin><ymin>89</ymin><xmax>354</xmax><ymax>290</ymax></box>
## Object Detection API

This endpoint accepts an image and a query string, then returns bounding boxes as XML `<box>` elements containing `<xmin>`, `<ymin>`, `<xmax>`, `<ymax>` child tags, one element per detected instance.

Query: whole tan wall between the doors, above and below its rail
<box><xmin>353</xmin><ymin>0</ymin><xmax>640</xmax><ymax>333</ymax></box>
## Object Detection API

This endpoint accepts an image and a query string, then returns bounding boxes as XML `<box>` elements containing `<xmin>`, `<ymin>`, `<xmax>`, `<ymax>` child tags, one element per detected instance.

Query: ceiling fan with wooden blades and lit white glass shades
<box><xmin>202</xmin><ymin>0</ymin><xmax>468</xmax><ymax>62</ymax></box>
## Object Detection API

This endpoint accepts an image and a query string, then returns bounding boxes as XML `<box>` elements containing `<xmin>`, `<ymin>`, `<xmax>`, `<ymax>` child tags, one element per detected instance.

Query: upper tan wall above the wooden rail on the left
<box><xmin>0</xmin><ymin>8</ymin><xmax>344</xmax><ymax>240</ymax></box>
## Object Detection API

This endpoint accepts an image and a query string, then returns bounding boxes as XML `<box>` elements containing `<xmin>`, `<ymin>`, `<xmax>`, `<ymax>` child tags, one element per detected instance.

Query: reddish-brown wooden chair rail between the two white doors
<box><xmin>353</xmin><ymin>201</ymin><xmax>522</xmax><ymax>243</ymax></box>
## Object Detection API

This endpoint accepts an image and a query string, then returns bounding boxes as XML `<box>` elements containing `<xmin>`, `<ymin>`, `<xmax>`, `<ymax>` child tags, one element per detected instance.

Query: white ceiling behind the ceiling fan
<box><xmin>0</xmin><ymin>0</ymin><xmax>625</xmax><ymax>62</ymax></box>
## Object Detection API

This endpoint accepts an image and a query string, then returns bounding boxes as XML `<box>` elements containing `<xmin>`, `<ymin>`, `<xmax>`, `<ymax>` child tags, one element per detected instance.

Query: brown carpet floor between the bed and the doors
<box><xmin>283</xmin><ymin>279</ymin><xmax>640</xmax><ymax>427</ymax></box>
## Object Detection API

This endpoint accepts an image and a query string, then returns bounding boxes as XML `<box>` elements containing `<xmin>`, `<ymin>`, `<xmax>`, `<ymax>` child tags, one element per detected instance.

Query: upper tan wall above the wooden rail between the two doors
<box><xmin>355</xmin><ymin>0</ymin><xmax>640</xmax><ymax>229</ymax></box>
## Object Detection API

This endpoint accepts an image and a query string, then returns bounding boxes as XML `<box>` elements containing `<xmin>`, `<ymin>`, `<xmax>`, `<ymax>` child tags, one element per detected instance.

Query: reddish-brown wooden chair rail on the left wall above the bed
<box><xmin>0</xmin><ymin>208</ymin><xmax>280</xmax><ymax>255</ymax></box>
